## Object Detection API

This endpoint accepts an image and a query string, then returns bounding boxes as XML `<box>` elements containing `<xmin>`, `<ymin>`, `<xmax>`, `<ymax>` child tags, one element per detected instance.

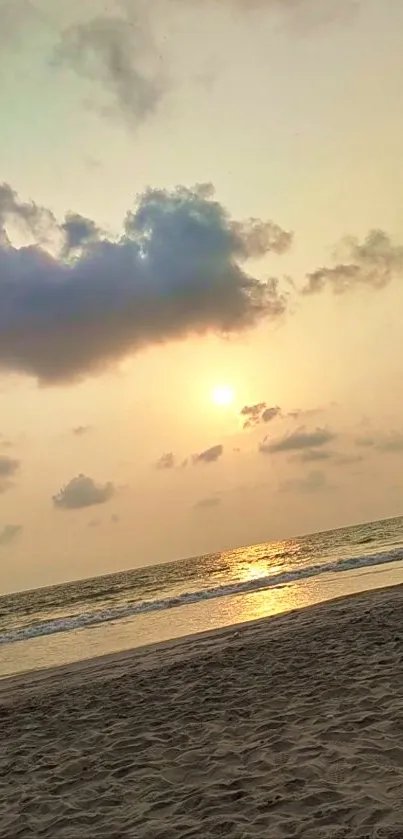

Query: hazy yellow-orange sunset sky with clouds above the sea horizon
<box><xmin>0</xmin><ymin>0</ymin><xmax>403</xmax><ymax>592</ymax></box>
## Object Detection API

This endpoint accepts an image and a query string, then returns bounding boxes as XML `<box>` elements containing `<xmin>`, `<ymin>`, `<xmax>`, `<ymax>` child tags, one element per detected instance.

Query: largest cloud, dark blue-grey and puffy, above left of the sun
<box><xmin>0</xmin><ymin>184</ymin><xmax>292</xmax><ymax>384</ymax></box>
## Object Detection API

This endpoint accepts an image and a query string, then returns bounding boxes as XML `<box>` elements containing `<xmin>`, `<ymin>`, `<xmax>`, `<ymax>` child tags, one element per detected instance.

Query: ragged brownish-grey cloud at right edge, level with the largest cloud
<box><xmin>302</xmin><ymin>230</ymin><xmax>403</xmax><ymax>295</ymax></box>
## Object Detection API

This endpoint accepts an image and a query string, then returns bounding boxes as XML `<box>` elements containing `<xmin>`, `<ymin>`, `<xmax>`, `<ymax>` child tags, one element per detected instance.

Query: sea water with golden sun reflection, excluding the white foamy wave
<box><xmin>0</xmin><ymin>517</ymin><xmax>403</xmax><ymax>676</ymax></box>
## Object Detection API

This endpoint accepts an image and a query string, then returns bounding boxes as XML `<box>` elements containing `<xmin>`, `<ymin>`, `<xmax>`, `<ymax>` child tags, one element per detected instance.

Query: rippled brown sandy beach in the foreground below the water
<box><xmin>0</xmin><ymin>587</ymin><xmax>403</xmax><ymax>839</ymax></box>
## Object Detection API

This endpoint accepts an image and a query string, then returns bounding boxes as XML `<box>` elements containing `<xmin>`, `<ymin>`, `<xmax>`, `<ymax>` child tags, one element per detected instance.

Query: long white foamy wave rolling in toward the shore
<box><xmin>0</xmin><ymin>548</ymin><xmax>403</xmax><ymax>644</ymax></box>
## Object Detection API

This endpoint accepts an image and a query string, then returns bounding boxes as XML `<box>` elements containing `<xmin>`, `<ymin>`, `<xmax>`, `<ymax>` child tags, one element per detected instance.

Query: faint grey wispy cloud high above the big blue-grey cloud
<box><xmin>55</xmin><ymin>14</ymin><xmax>165</xmax><ymax>125</ymax></box>
